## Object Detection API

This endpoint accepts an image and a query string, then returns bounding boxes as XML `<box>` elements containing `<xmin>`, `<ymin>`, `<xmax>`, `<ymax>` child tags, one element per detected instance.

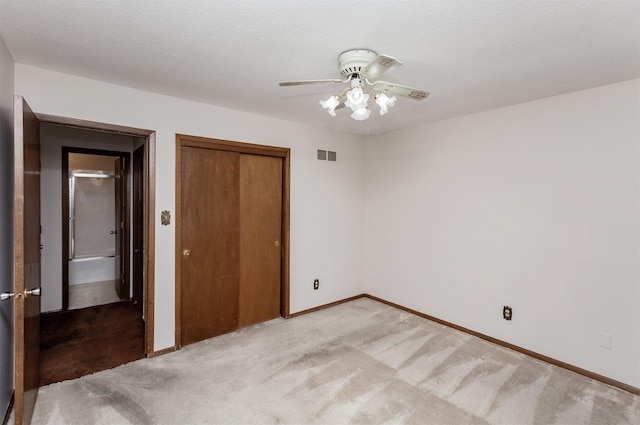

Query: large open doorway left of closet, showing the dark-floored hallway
<box><xmin>38</xmin><ymin>115</ymin><xmax>155</xmax><ymax>384</ymax></box>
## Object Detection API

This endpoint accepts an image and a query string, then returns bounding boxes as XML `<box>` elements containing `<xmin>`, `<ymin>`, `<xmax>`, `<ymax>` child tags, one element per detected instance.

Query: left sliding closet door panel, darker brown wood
<box><xmin>180</xmin><ymin>147</ymin><xmax>240</xmax><ymax>345</ymax></box>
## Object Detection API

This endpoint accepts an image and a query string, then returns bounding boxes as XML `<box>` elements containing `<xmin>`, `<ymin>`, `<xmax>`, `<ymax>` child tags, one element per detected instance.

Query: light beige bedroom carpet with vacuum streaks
<box><xmin>23</xmin><ymin>298</ymin><xmax>640</xmax><ymax>425</ymax></box>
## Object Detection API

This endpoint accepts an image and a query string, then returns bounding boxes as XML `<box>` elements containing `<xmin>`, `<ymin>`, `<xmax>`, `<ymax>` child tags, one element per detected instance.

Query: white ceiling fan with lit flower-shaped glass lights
<box><xmin>280</xmin><ymin>49</ymin><xmax>429</xmax><ymax>120</ymax></box>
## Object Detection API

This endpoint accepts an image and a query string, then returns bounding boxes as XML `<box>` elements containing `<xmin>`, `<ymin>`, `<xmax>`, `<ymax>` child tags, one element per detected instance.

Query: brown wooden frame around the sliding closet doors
<box><xmin>175</xmin><ymin>134</ymin><xmax>290</xmax><ymax>349</ymax></box>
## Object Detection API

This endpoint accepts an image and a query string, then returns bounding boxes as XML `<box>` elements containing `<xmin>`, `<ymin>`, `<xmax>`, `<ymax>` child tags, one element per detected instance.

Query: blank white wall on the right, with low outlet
<box><xmin>365</xmin><ymin>80</ymin><xmax>640</xmax><ymax>387</ymax></box>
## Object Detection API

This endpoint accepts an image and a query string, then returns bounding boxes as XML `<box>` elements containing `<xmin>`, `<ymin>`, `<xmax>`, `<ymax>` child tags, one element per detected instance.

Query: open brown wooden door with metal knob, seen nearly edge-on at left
<box><xmin>13</xmin><ymin>96</ymin><xmax>40</xmax><ymax>425</ymax></box>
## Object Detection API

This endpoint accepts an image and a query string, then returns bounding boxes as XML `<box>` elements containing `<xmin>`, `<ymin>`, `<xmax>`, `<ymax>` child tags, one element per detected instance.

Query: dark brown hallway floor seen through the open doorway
<box><xmin>40</xmin><ymin>302</ymin><xmax>144</xmax><ymax>385</ymax></box>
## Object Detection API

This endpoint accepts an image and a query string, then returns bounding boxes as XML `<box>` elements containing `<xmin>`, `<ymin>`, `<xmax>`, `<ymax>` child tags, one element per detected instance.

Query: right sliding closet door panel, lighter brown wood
<box><xmin>239</xmin><ymin>154</ymin><xmax>282</xmax><ymax>326</ymax></box>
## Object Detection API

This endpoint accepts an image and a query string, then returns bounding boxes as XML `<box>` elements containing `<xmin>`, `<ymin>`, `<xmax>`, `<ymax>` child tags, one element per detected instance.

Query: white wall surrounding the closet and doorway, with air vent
<box><xmin>15</xmin><ymin>64</ymin><xmax>364</xmax><ymax>350</ymax></box>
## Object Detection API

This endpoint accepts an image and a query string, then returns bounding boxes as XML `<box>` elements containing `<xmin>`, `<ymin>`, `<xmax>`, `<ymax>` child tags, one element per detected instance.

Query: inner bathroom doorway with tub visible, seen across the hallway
<box><xmin>62</xmin><ymin>147</ymin><xmax>129</xmax><ymax>310</ymax></box>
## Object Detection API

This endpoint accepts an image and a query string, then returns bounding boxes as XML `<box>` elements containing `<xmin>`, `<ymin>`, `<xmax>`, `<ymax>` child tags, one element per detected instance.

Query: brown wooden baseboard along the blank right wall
<box><xmin>364</xmin><ymin>294</ymin><xmax>640</xmax><ymax>395</ymax></box>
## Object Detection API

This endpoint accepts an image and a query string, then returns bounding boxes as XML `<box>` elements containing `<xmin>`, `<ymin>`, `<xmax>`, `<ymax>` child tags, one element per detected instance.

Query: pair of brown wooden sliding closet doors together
<box><xmin>178</xmin><ymin>141</ymin><xmax>283</xmax><ymax>345</ymax></box>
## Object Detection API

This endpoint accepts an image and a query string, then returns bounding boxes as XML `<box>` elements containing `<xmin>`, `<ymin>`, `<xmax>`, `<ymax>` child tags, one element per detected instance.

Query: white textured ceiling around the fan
<box><xmin>0</xmin><ymin>0</ymin><xmax>640</xmax><ymax>134</ymax></box>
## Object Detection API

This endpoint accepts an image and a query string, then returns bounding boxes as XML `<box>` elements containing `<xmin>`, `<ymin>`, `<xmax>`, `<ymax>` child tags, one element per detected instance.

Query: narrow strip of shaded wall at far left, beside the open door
<box><xmin>0</xmin><ymin>34</ymin><xmax>14</xmax><ymax>416</ymax></box>
